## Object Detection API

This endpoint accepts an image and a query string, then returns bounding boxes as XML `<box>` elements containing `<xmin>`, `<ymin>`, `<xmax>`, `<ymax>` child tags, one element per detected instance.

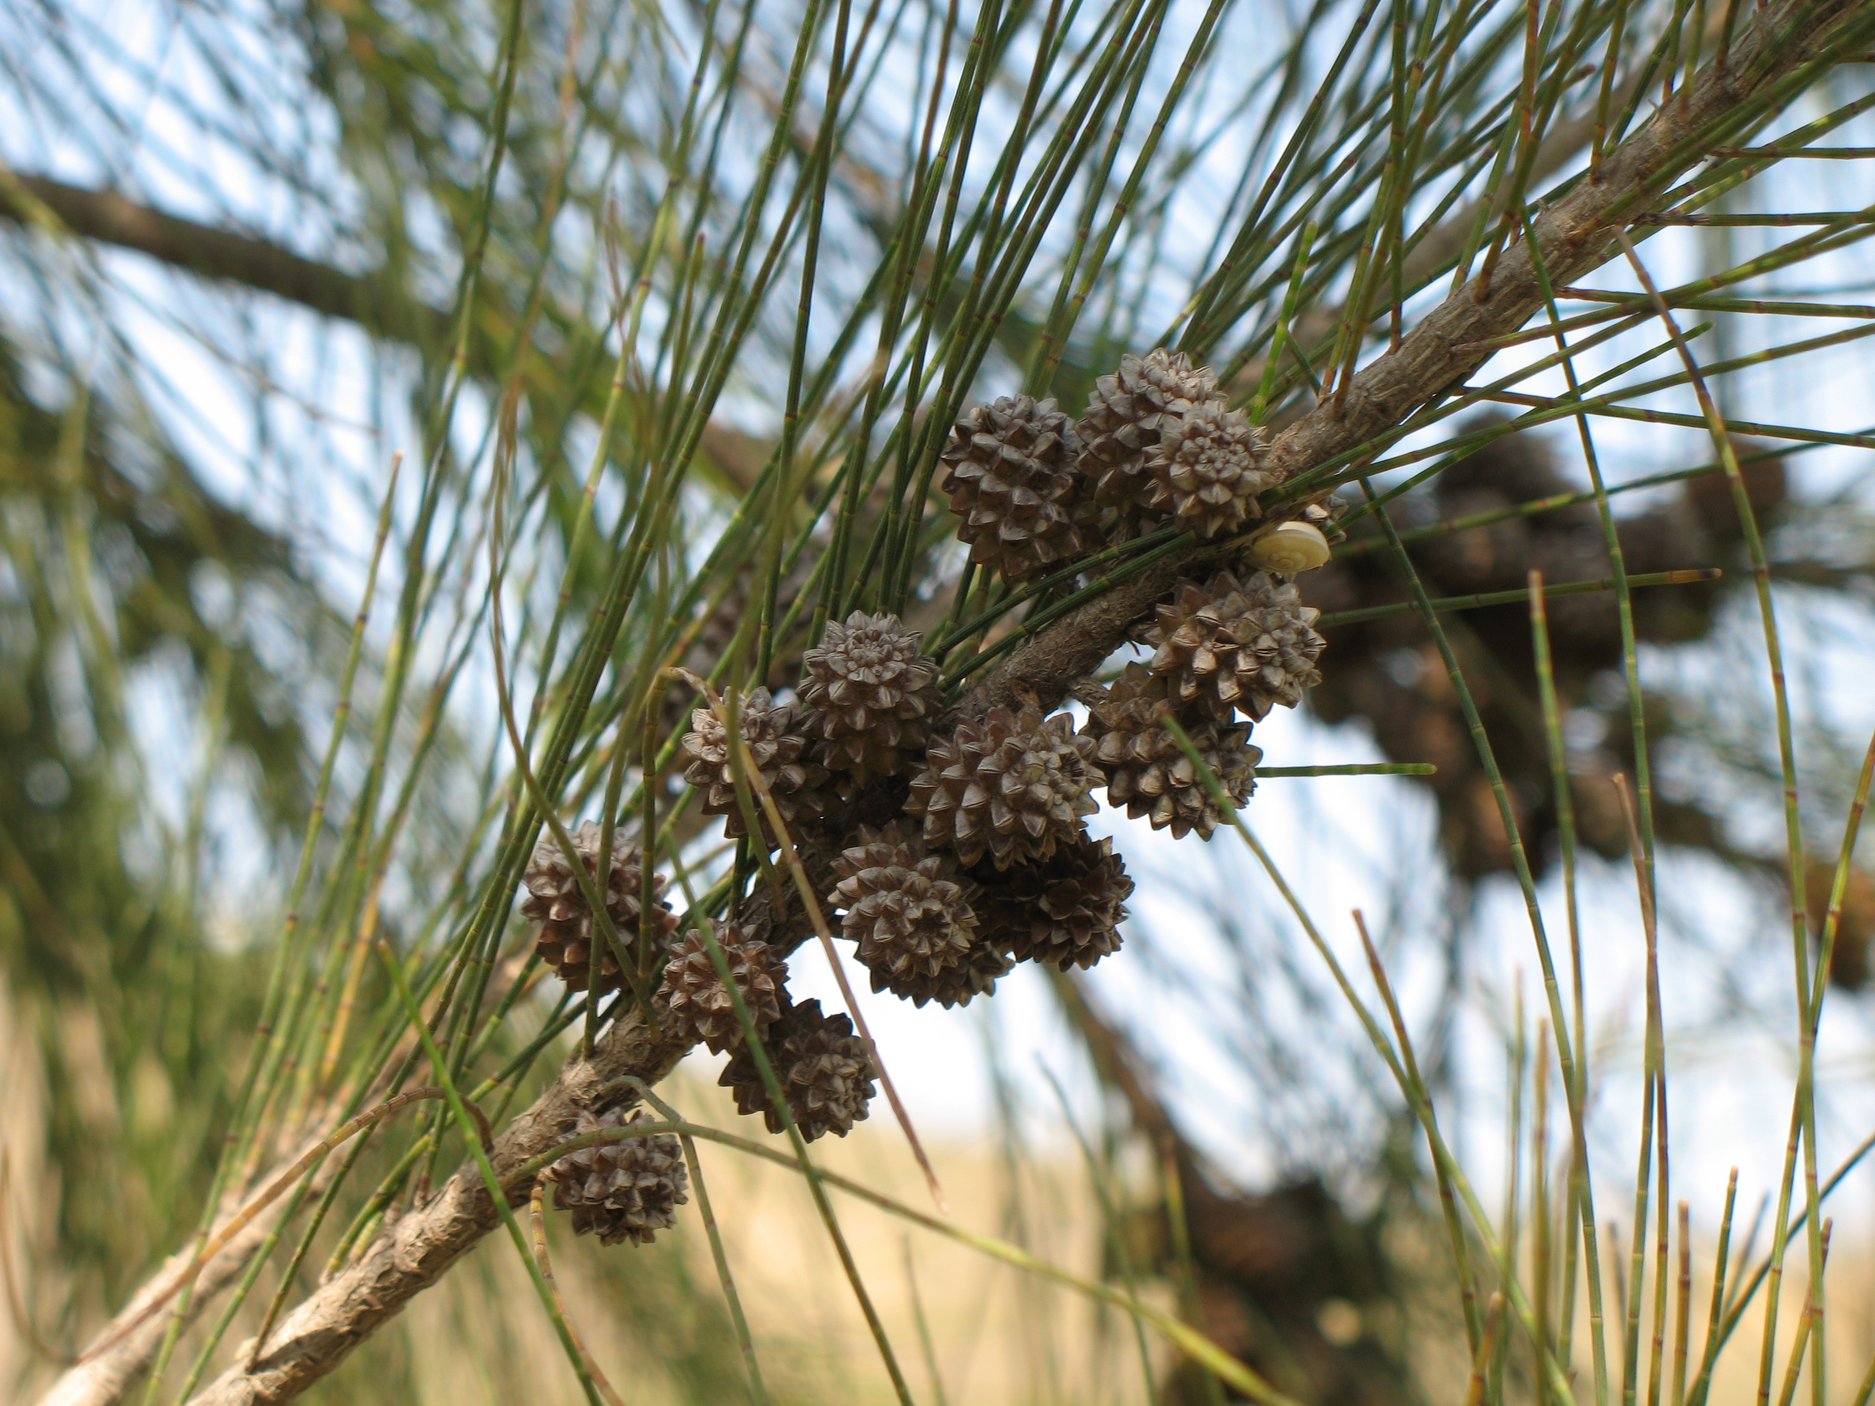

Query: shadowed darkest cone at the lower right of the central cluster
<box><xmin>979</xmin><ymin>838</ymin><xmax>1133</xmax><ymax>971</ymax></box>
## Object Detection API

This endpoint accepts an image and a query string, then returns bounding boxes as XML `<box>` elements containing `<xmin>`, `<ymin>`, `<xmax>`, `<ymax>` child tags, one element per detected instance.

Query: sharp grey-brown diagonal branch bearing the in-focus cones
<box><xmin>33</xmin><ymin>0</ymin><xmax>1866</xmax><ymax>1406</ymax></box>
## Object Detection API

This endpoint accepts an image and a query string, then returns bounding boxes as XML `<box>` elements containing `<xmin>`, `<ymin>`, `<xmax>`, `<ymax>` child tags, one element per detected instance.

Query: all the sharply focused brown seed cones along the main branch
<box><xmin>523</xmin><ymin>351</ymin><xmax>1329</xmax><ymax>1241</ymax></box>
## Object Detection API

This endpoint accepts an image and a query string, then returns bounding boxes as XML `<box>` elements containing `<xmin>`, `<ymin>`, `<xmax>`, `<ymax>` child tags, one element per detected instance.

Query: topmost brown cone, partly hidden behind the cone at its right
<box><xmin>1080</xmin><ymin>347</ymin><xmax>1217</xmax><ymax>540</ymax></box>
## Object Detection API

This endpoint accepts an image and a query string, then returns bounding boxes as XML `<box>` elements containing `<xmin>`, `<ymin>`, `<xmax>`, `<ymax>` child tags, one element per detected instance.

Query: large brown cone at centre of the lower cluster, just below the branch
<box><xmin>906</xmin><ymin>707</ymin><xmax>1106</xmax><ymax>868</ymax></box>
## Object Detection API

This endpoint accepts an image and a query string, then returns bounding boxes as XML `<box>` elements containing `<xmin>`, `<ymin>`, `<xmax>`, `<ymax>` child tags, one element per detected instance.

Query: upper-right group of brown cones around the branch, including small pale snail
<box><xmin>937</xmin><ymin>349</ymin><xmax>1333</xmax><ymax>838</ymax></box>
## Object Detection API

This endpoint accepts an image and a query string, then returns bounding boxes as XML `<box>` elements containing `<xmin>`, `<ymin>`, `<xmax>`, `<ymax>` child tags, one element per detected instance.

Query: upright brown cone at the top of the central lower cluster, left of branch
<box><xmin>801</xmin><ymin>611</ymin><xmax>941</xmax><ymax>782</ymax></box>
